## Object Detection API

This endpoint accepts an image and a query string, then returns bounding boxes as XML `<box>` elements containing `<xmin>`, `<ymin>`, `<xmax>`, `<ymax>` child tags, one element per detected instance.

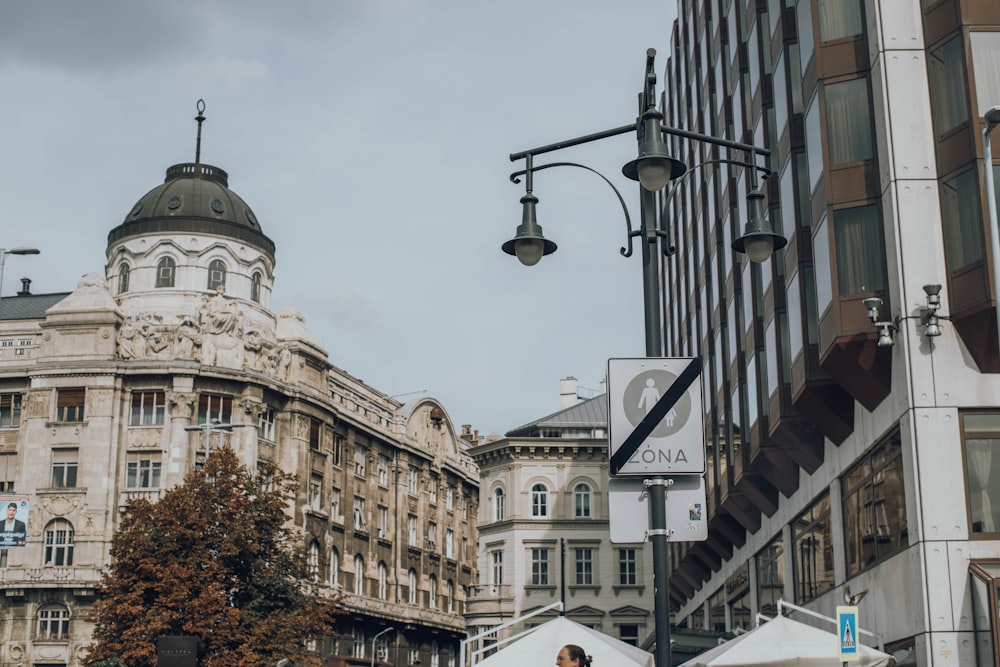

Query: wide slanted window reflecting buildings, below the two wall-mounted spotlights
<box><xmin>841</xmin><ymin>431</ymin><xmax>908</xmax><ymax>576</ymax></box>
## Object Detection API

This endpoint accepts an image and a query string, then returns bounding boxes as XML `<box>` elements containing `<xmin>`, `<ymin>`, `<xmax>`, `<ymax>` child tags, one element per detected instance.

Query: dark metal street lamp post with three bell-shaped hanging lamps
<box><xmin>502</xmin><ymin>49</ymin><xmax>786</xmax><ymax>667</ymax></box>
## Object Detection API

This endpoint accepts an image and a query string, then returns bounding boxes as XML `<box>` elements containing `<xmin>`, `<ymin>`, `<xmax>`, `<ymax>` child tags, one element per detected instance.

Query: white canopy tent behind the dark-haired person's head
<box><xmin>473</xmin><ymin>616</ymin><xmax>655</xmax><ymax>667</ymax></box>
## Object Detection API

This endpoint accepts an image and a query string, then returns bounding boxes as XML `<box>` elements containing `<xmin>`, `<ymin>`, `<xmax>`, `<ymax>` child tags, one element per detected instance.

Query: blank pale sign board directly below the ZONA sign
<box><xmin>608</xmin><ymin>475</ymin><xmax>708</xmax><ymax>544</ymax></box>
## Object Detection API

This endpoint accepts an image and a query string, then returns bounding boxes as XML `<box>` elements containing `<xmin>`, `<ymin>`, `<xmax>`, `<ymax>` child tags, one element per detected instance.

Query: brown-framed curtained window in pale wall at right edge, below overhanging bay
<box><xmin>962</xmin><ymin>412</ymin><xmax>1000</xmax><ymax>535</ymax></box>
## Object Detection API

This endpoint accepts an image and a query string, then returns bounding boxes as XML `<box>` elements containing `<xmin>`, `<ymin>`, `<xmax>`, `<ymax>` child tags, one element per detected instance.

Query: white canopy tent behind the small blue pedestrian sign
<box><xmin>676</xmin><ymin>616</ymin><xmax>896</xmax><ymax>667</ymax></box>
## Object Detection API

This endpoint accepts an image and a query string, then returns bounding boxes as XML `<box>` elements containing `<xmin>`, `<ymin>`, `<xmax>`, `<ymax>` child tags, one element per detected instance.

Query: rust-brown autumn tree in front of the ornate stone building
<box><xmin>88</xmin><ymin>447</ymin><xmax>335</xmax><ymax>667</ymax></box>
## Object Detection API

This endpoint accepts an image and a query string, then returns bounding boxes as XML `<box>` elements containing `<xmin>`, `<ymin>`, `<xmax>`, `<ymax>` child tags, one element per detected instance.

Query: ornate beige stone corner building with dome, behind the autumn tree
<box><xmin>0</xmin><ymin>117</ymin><xmax>478</xmax><ymax>667</ymax></box>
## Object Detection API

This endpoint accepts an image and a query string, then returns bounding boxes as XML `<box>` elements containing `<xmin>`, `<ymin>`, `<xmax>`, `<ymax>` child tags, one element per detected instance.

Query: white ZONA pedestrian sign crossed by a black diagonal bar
<box><xmin>608</xmin><ymin>357</ymin><xmax>705</xmax><ymax>477</ymax></box>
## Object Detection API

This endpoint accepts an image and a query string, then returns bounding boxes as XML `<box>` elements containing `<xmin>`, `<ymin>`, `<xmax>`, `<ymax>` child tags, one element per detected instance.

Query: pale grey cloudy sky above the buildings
<box><xmin>0</xmin><ymin>0</ymin><xmax>676</xmax><ymax>435</ymax></box>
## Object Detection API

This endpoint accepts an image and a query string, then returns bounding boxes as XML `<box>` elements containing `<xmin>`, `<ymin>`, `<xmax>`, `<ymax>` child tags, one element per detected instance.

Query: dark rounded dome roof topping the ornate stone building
<box><xmin>108</xmin><ymin>162</ymin><xmax>274</xmax><ymax>259</ymax></box>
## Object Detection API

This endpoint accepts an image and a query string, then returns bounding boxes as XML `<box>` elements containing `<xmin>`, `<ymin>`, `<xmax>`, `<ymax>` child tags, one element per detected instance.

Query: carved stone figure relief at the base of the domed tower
<box><xmin>117</xmin><ymin>288</ymin><xmax>292</xmax><ymax>382</ymax></box>
